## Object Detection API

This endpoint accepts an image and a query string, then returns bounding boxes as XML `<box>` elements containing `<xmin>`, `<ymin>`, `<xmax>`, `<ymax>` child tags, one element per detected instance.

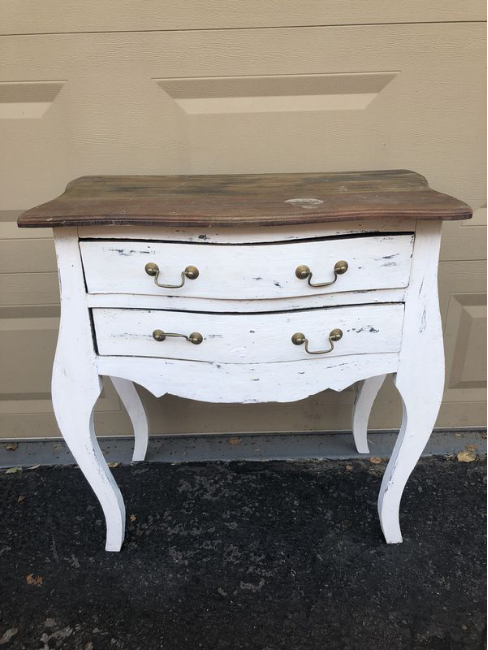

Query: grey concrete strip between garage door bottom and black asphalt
<box><xmin>0</xmin><ymin>429</ymin><xmax>486</xmax><ymax>468</ymax></box>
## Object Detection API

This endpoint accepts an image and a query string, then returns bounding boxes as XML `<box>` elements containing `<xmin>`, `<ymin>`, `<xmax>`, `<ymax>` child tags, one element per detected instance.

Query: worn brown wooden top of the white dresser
<box><xmin>18</xmin><ymin>170</ymin><xmax>472</xmax><ymax>228</ymax></box>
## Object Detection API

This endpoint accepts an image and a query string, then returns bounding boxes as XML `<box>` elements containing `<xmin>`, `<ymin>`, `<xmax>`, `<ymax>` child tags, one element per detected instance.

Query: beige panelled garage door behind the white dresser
<box><xmin>0</xmin><ymin>0</ymin><xmax>486</xmax><ymax>437</ymax></box>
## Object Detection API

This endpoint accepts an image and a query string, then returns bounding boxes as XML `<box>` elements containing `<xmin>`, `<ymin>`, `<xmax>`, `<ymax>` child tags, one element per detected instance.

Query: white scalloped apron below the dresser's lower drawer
<box><xmin>96</xmin><ymin>353</ymin><xmax>398</xmax><ymax>404</ymax></box>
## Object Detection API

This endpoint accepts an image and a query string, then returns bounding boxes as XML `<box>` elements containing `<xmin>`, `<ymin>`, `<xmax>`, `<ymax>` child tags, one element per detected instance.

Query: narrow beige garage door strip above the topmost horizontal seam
<box><xmin>0</xmin><ymin>0</ymin><xmax>486</xmax><ymax>34</ymax></box>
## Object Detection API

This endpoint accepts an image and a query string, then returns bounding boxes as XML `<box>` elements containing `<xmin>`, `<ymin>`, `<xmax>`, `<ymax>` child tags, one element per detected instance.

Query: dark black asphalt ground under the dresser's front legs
<box><xmin>0</xmin><ymin>457</ymin><xmax>486</xmax><ymax>650</ymax></box>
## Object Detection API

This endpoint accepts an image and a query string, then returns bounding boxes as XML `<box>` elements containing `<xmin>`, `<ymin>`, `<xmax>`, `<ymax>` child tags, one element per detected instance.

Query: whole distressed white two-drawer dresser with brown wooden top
<box><xmin>19</xmin><ymin>170</ymin><xmax>471</xmax><ymax>551</ymax></box>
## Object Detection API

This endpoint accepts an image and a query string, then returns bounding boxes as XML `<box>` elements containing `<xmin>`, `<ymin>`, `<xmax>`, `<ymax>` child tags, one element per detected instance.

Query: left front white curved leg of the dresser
<box><xmin>52</xmin><ymin>228</ymin><xmax>125</xmax><ymax>551</ymax></box>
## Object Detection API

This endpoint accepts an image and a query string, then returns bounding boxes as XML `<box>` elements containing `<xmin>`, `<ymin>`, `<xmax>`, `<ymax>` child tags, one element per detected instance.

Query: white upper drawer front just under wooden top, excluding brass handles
<box><xmin>80</xmin><ymin>234</ymin><xmax>414</xmax><ymax>300</ymax></box>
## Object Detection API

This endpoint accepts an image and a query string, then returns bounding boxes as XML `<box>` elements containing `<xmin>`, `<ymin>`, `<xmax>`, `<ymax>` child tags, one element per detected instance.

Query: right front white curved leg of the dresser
<box><xmin>378</xmin><ymin>222</ymin><xmax>444</xmax><ymax>544</ymax></box>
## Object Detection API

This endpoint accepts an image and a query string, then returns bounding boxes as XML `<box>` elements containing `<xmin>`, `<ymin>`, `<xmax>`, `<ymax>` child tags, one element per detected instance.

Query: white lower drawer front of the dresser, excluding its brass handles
<box><xmin>92</xmin><ymin>304</ymin><xmax>404</xmax><ymax>363</ymax></box>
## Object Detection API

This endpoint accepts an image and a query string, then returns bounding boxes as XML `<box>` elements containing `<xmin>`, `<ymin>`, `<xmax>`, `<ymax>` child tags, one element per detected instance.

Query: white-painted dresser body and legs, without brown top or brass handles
<box><xmin>53</xmin><ymin>219</ymin><xmax>444</xmax><ymax>550</ymax></box>
